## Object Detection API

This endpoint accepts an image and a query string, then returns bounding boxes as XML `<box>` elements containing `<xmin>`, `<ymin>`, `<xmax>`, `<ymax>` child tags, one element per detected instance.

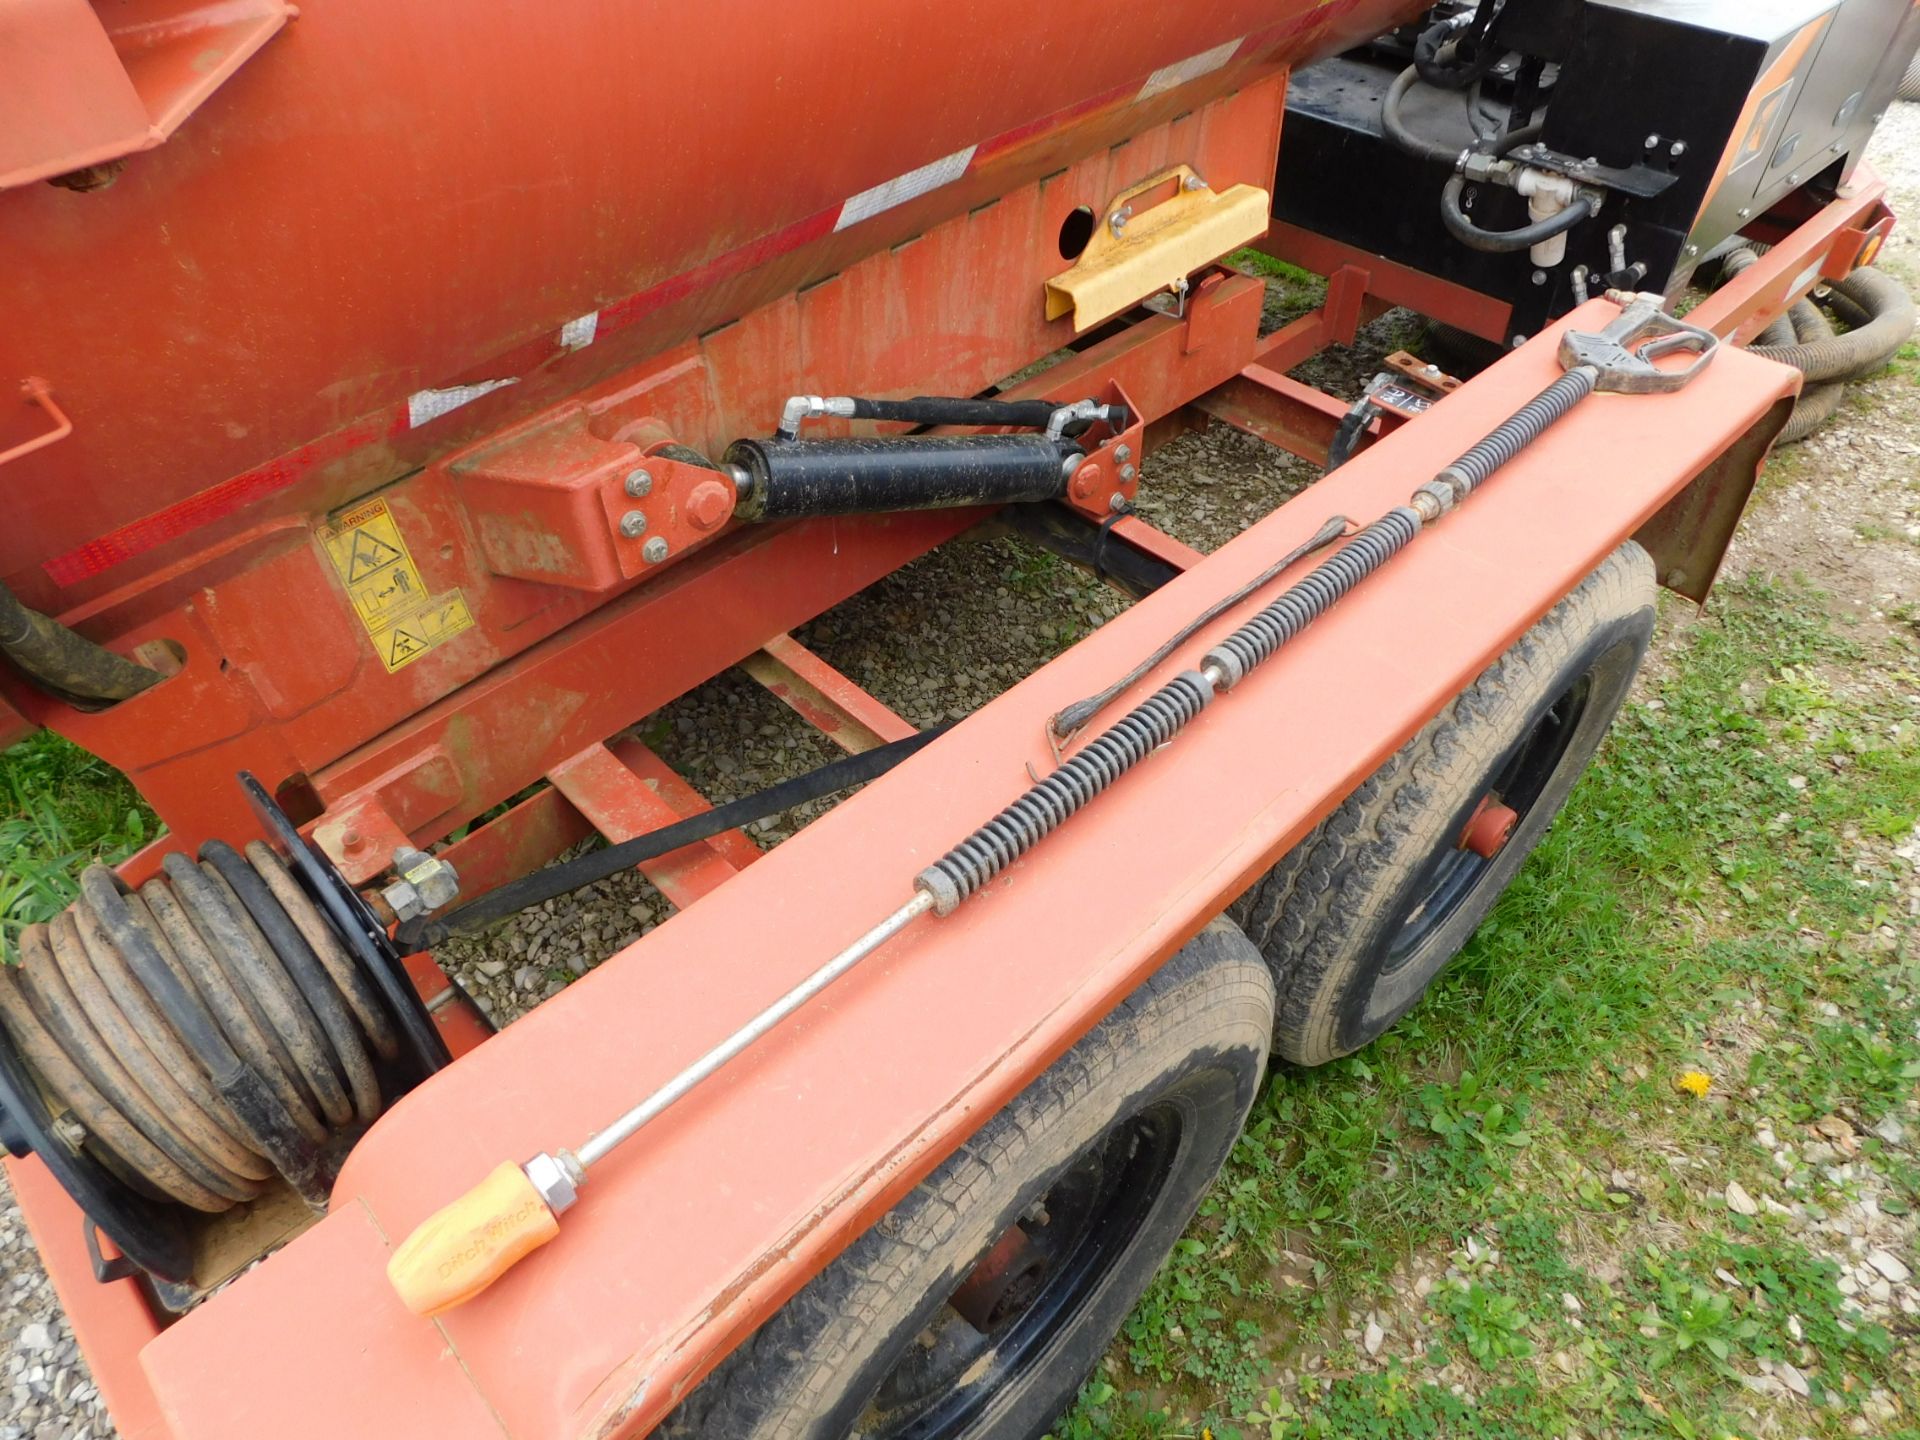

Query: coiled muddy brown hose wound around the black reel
<box><xmin>0</xmin><ymin>841</ymin><xmax>399</xmax><ymax>1213</ymax></box>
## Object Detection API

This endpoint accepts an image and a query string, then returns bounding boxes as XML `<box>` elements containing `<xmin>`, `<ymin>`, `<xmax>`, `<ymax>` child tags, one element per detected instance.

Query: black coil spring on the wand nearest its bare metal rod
<box><xmin>914</xmin><ymin>670</ymin><xmax>1213</xmax><ymax>916</ymax></box>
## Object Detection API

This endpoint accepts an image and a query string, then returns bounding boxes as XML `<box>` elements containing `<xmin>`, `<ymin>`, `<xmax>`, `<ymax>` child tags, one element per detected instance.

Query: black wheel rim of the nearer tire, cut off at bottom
<box><xmin>852</xmin><ymin>1104</ymin><xmax>1185</xmax><ymax>1440</ymax></box>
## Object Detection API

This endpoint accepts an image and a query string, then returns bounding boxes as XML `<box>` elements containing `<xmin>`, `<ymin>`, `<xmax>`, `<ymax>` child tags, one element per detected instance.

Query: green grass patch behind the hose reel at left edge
<box><xmin>0</xmin><ymin>732</ymin><xmax>157</xmax><ymax>960</ymax></box>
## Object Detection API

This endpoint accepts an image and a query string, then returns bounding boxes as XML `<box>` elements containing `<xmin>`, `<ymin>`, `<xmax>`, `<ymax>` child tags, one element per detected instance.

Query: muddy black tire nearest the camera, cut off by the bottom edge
<box><xmin>659</xmin><ymin>920</ymin><xmax>1273</xmax><ymax>1440</ymax></box>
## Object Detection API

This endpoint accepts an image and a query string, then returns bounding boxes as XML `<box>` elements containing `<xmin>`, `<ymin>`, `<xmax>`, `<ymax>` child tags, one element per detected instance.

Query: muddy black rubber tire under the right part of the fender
<box><xmin>1229</xmin><ymin>541</ymin><xmax>1655</xmax><ymax>1066</ymax></box>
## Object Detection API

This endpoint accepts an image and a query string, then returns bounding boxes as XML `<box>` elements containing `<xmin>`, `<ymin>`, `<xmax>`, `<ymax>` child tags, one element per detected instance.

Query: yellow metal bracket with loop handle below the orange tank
<box><xmin>1046</xmin><ymin>165</ymin><xmax>1271</xmax><ymax>332</ymax></box>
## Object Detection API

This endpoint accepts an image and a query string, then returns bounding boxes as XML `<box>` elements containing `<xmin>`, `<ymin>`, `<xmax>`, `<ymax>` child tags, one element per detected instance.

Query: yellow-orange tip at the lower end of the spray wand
<box><xmin>386</xmin><ymin>1160</ymin><xmax>561</xmax><ymax>1315</ymax></box>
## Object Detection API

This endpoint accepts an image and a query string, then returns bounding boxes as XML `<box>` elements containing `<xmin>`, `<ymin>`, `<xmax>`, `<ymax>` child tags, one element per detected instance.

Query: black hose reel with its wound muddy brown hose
<box><xmin>0</xmin><ymin>776</ymin><xmax>451</xmax><ymax>1308</ymax></box>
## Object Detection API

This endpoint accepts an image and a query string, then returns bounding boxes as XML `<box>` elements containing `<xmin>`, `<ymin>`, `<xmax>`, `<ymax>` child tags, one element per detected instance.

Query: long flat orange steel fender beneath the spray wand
<box><xmin>146</xmin><ymin>318</ymin><xmax>1793</xmax><ymax>1440</ymax></box>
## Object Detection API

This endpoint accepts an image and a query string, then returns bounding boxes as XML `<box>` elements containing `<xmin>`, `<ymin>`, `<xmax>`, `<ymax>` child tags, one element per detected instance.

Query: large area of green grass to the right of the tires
<box><xmin>1056</xmin><ymin>582</ymin><xmax>1920</xmax><ymax>1440</ymax></box>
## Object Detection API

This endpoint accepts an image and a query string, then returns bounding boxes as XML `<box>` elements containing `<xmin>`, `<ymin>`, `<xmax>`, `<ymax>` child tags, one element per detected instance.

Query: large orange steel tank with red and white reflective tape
<box><xmin>0</xmin><ymin>0</ymin><xmax>1419</xmax><ymax>601</ymax></box>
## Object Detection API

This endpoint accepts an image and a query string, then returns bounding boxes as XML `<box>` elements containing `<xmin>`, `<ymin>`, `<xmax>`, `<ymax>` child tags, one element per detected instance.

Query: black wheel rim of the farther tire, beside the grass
<box><xmin>1380</xmin><ymin>670</ymin><xmax>1594</xmax><ymax>977</ymax></box>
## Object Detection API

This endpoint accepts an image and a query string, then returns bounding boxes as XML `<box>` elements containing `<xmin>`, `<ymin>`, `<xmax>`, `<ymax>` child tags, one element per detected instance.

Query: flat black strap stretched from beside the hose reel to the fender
<box><xmin>394</xmin><ymin>726</ymin><xmax>948</xmax><ymax>954</ymax></box>
